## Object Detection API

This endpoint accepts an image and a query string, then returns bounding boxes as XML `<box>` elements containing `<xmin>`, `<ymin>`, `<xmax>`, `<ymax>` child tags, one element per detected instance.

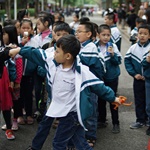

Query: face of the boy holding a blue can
<box><xmin>98</xmin><ymin>29</ymin><xmax>111</xmax><ymax>45</ymax></box>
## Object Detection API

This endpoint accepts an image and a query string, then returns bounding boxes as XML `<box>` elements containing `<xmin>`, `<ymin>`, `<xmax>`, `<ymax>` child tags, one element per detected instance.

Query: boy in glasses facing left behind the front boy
<box><xmin>76</xmin><ymin>22</ymin><xmax>104</xmax><ymax>147</ymax></box>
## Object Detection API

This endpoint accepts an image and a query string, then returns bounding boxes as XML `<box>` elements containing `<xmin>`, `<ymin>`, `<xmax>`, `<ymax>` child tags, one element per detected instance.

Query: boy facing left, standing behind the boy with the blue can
<box><xmin>104</xmin><ymin>13</ymin><xmax>121</xmax><ymax>51</ymax></box>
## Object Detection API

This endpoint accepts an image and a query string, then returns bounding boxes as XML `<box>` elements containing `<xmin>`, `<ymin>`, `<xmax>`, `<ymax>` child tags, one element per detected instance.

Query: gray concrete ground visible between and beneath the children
<box><xmin>0</xmin><ymin>15</ymin><xmax>149</xmax><ymax>150</ymax></box>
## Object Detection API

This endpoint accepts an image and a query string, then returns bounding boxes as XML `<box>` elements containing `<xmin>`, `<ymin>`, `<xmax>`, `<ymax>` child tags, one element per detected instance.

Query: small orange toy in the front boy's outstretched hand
<box><xmin>112</xmin><ymin>96</ymin><xmax>132</xmax><ymax>110</ymax></box>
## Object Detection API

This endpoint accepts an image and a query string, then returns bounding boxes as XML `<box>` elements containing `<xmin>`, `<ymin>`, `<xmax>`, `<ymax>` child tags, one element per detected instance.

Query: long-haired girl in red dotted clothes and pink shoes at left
<box><xmin>2</xmin><ymin>25</ymin><xmax>23</xmax><ymax>130</ymax></box>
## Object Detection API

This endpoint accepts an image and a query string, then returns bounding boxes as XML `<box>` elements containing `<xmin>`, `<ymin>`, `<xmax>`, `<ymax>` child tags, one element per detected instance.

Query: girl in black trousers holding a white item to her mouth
<box><xmin>18</xmin><ymin>18</ymin><xmax>38</xmax><ymax>124</ymax></box>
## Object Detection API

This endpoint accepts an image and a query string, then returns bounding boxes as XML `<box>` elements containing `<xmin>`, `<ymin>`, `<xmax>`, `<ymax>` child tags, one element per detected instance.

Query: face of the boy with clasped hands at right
<box><xmin>138</xmin><ymin>28</ymin><xmax>150</xmax><ymax>44</ymax></box>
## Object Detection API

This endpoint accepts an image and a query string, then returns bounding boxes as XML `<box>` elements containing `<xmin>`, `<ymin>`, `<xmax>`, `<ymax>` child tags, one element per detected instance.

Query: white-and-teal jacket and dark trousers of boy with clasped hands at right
<box><xmin>124</xmin><ymin>41</ymin><xmax>150</xmax><ymax>124</ymax></box>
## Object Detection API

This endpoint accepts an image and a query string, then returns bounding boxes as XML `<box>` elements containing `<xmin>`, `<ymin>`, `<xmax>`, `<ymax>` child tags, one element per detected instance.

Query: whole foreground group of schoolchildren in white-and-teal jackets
<box><xmin>0</xmin><ymin>7</ymin><xmax>150</xmax><ymax>150</ymax></box>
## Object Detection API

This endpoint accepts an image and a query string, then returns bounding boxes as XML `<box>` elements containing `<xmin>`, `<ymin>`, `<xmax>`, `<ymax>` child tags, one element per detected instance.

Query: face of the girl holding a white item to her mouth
<box><xmin>20</xmin><ymin>22</ymin><xmax>33</xmax><ymax>36</ymax></box>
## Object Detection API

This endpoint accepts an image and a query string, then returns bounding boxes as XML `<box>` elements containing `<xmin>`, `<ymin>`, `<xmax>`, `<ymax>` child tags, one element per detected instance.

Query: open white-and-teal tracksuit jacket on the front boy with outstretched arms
<box><xmin>19</xmin><ymin>47</ymin><xmax>115</xmax><ymax>129</ymax></box>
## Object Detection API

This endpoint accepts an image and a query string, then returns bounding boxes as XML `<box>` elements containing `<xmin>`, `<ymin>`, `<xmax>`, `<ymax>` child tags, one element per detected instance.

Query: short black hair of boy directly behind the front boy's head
<box><xmin>54</xmin><ymin>22</ymin><xmax>71</xmax><ymax>34</ymax></box>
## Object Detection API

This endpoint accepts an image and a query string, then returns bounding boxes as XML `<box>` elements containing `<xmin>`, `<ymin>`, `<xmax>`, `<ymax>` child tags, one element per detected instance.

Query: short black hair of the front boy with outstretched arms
<box><xmin>56</xmin><ymin>34</ymin><xmax>81</xmax><ymax>59</ymax></box>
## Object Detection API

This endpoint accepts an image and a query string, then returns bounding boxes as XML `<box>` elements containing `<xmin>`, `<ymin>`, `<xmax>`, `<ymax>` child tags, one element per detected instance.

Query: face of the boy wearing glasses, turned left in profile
<box><xmin>76</xmin><ymin>25</ymin><xmax>92</xmax><ymax>43</ymax></box>
